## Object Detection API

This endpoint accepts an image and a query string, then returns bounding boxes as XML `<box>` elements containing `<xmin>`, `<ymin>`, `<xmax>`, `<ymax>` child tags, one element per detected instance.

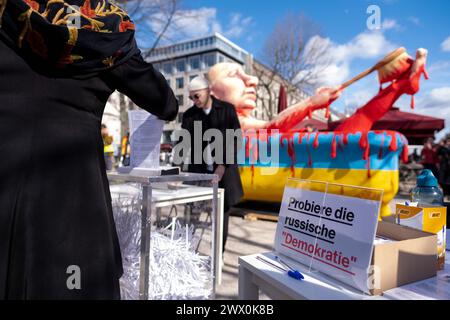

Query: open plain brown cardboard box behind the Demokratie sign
<box><xmin>370</xmin><ymin>221</ymin><xmax>437</xmax><ymax>295</ymax></box>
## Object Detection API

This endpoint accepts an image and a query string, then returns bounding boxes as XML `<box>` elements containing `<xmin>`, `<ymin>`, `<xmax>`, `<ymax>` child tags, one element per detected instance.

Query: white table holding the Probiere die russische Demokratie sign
<box><xmin>239</xmin><ymin>252</ymin><xmax>450</xmax><ymax>300</ymax></box>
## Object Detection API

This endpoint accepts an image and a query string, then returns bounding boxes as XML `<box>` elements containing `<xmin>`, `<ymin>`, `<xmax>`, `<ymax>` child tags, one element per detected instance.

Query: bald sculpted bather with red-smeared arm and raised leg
<box><xmin>209</xmin><ymin>49</ymin><xmax>428</xmax><ymax>132</ymax></box>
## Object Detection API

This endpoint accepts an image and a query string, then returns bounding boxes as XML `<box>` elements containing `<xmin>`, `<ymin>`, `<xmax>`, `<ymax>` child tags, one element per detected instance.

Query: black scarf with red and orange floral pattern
<box><xmin>0</xmin><ymin>0</ymin><xmax>139</xmax><ymax>75</ymax></box>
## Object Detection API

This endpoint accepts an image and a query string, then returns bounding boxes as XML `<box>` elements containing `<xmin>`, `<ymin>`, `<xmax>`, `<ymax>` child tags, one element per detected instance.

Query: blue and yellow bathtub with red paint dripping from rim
<box><xmin>240</xmin><ymin>131</ymin><xmax>408</xmax><ymax>217</ymax></box>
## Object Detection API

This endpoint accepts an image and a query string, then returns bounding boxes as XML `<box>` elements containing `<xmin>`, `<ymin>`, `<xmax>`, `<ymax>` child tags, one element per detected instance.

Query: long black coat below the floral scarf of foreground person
<box><xmin>0</xmin><ymin>30</ymin><xmax>178</xmax><ymax>299</ymax></box>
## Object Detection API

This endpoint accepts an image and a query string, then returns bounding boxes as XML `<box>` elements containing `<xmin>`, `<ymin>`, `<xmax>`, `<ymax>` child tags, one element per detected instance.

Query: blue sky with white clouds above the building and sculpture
<box><xmin>132</xmin><ymin>0</ymin><xmax>450</xmax><ymax>136</ymax></box>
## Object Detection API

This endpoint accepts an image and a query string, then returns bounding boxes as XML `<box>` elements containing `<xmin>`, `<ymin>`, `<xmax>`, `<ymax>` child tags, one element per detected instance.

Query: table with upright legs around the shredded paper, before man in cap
<box><xmin>108</xmin><ymin>172</ymin><xmax>224</xmax><ymax>300</ymax></box>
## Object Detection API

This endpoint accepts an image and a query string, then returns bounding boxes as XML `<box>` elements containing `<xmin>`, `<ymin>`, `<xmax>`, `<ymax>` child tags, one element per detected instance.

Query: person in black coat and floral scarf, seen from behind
<box><xmin>0</xmin><ymin>0</ymin><xmax>178</xmax><ymax>300</ymax></box>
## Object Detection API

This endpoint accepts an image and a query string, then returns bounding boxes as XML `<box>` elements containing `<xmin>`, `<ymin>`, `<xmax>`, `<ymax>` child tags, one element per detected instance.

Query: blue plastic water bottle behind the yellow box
<box><xmin>411</xmin><ymin>169</ymin><xmax>444</xmax><ymax>207</ymax></box>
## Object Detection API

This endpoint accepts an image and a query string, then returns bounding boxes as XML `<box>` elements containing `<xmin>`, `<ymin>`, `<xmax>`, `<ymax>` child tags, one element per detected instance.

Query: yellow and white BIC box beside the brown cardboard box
<box><xmin>395</xmin><ymin>204</ymin><xmax>447</xmax><ymax>270</ymax></box>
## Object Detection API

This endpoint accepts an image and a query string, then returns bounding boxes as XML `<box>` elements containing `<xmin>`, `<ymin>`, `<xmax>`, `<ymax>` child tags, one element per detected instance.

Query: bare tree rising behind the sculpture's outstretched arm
<box><xmin>254</xmin><ymin>14</ymin><xmax>331</xmax><ymax>120</ymax></box>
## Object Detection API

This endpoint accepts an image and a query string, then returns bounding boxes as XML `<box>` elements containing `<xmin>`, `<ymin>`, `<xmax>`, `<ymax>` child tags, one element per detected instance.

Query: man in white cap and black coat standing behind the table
<box><xmin>182</xmin><ymin>77</ymin><xmax>244</xmax><ymax>251</ymax></box>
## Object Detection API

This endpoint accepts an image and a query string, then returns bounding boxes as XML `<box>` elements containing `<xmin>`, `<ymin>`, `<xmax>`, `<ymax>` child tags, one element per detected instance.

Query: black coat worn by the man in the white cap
<box><xmin>182</xmin><ymin>97</ymin><xmax>244</xmax><ymax>206</ymax></box>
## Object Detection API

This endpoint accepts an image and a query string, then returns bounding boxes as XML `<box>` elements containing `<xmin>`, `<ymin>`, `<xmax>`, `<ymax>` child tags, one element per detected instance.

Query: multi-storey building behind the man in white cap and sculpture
<box><xmin>104</xmin><ymin>33</ymin><xmax>326</xmax><ymax>149</ymax></box>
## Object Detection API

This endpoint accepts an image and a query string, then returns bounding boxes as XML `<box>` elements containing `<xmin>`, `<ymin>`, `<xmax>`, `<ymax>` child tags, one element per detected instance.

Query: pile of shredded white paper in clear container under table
<box><xmin>111</xmin><ymin>185</ymin><xmax>213</xmax><ymax>300</ymax></box>
